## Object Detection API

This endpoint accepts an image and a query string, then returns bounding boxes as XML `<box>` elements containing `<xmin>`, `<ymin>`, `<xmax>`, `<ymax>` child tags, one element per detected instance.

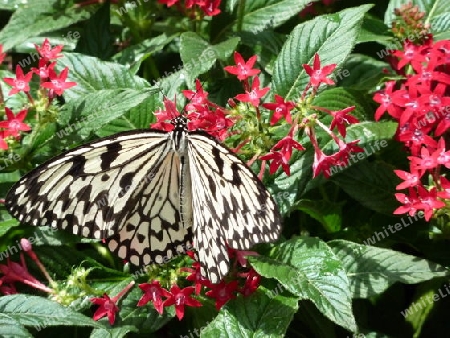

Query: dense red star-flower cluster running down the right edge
<box><xmin>374</xmin><ymin>35</ymin><xmax>450</xmax><ymax>221</ymax></box>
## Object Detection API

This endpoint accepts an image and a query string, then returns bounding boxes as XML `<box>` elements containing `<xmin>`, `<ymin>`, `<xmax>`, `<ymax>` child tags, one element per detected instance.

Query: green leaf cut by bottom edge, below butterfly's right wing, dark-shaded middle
<box><xmin>199</xmin><ymin>286</ymin><xmax>298</xmax><ymax>338</ymax></box>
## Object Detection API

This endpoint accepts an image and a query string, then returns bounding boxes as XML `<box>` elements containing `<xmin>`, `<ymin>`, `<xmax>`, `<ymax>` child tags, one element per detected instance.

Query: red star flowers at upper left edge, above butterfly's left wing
<box><xmin>0</xmin><ymin>39</ymin><xmax>76</xmax><ymax>150</ymax></box>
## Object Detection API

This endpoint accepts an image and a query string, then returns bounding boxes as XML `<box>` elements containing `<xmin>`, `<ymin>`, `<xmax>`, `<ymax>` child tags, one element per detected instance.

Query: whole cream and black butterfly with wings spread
<box><xmin>5</xmin><ymin>115</ymin><xmax>281</xmax><ymax>283</ymax></box>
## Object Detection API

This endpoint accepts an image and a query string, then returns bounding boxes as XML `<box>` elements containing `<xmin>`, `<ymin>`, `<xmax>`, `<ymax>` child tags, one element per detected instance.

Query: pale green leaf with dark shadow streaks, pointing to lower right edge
<box><xmin>328</xmin><ymin>240</ymin><xmax>449</xmax><ymax>298</ymax></box>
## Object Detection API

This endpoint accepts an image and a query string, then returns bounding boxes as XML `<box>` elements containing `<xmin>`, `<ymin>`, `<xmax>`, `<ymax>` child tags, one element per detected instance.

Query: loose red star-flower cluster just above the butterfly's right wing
<box><xmin>224</xmin><ymin>53</ymin><xmax>363</xmax><ymax>177</ymax></box>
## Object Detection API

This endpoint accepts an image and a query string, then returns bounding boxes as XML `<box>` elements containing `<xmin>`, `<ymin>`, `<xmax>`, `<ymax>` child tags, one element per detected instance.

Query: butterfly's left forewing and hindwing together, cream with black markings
<box><xmin>5</xmin><ymin>129</ymin><xmax>192</xmax><ymax>265</ymax></box>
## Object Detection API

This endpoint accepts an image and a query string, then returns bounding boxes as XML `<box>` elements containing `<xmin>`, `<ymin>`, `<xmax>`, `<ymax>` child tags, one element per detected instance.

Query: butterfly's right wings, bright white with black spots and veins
<box><xmin>188</xmin><ymin>131</ymin><xmax>281</xmax><ymax>283</ymax></box>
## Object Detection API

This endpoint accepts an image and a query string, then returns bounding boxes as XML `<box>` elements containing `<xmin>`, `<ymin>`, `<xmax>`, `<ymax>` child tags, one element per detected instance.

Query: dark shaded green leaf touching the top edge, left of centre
<box><xmin>75</xmin><ymin>2</ymin><xmax>114</xmax><ymax>60</ymax></box>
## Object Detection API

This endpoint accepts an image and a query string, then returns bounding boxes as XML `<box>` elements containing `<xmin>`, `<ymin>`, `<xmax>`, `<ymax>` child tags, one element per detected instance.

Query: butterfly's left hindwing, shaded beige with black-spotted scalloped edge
<box><xmin>107</xmin><ymin>151</ymin><xmax>192</xmax><ymax>266</ymax></box>
